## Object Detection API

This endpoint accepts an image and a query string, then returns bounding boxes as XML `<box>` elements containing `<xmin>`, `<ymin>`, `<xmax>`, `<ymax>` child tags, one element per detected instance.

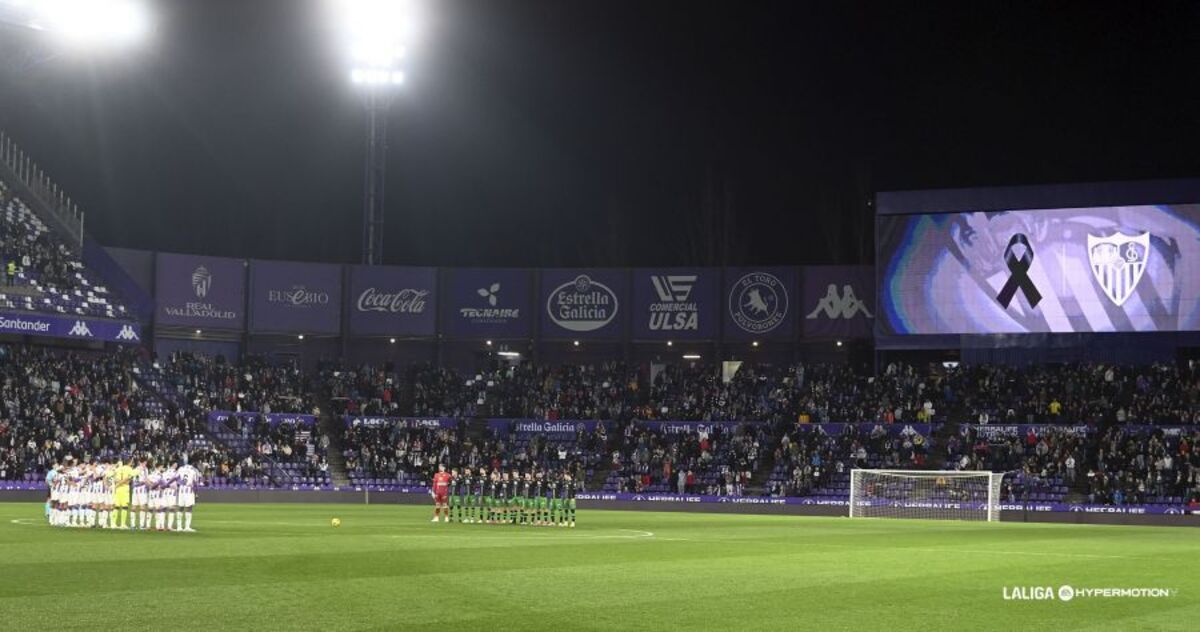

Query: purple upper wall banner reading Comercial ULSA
<box><xmin>630</xmin><ymin>267</ymin><xmax>721</xmax><ymax>341</ymax></box>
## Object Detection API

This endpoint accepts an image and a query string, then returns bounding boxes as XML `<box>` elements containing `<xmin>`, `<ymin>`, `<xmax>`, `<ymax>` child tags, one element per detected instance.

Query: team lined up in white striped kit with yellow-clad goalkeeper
<box><xmin>46</xmin><ymin>459</ymin><xmax>202</xmax><ymax>532</ymax></box>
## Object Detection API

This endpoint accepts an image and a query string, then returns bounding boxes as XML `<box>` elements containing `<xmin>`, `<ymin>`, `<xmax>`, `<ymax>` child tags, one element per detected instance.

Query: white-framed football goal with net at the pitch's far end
<box><xmin>850</xmin><ymin>469</ymin><xmax>1004</xmax><ymax>522</ymax></box>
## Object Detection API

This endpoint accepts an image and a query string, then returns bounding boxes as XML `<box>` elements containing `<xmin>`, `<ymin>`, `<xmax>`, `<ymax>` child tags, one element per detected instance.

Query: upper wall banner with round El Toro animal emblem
<box><xmin>721</xmin><ymin>267</ymin><xmax>799</xmax><ymax>341</ymax></box>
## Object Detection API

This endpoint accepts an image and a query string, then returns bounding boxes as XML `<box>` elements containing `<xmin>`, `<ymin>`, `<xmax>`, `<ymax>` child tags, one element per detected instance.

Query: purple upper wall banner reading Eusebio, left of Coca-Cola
<box><xmin>250</xmin><ymin>260</ymin><xmax>342</xmax><ymax>335</ymax></box>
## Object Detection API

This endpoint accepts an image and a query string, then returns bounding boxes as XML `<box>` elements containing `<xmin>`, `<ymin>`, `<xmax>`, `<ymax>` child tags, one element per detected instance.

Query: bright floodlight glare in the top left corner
<box><xmin>0</xmin><ymin>0</ymin><xmax>151</xmax><ymax>47</ymax></box>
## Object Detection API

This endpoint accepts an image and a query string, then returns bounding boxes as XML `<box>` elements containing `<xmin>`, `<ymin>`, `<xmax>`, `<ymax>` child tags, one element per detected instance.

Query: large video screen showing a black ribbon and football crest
<box><xmin>876</xmin><ymin>204</ymin><xmax>1200</xmax><ymax>335</ymax></box>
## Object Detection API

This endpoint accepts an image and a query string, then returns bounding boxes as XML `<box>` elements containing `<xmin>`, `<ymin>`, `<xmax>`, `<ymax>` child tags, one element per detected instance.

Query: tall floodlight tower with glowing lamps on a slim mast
<box><xmin>341</xmin><ymin>0</ymin><xmax>412</xmax><ymax>265</ymax></box>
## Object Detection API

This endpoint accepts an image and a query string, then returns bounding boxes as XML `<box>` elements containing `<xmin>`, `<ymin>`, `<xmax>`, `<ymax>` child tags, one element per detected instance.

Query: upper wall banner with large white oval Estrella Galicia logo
<box><xmin>538</xmin><ymin>270</ymin><xmax>629</xmax><ymax>339</ymax></box>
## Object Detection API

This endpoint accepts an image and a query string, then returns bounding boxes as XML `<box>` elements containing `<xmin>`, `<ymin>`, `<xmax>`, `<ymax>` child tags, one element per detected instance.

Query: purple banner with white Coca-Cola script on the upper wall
<box><xmin>347</xmin><ymin>265</ymin><xmax>437</xmax><ymax>336</ymax></box>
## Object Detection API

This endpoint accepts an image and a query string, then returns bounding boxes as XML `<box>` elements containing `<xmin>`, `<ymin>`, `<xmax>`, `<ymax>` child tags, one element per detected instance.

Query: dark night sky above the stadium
<box><xmin>0</xmin><ymin>0</ymin><xmax>1200</xmax><ymax>266</ymax></box>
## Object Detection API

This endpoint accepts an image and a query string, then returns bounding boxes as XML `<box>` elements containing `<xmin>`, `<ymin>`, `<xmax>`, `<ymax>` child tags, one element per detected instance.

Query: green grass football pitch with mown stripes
<box><xmin>0</xmin><ymin>502</ymin><xmax>1200</xmax><ymax>632</ymax></box>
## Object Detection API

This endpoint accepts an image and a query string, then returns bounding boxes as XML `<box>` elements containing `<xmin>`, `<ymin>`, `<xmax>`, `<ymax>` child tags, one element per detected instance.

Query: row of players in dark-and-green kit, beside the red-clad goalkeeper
<box><xmin>449</xmin><ymin>468</ymin><xmax>577</xmax><ymax>528</ymax></box>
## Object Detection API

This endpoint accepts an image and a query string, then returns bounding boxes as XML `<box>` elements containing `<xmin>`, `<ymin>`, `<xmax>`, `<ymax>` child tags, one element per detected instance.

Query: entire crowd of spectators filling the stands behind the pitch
<box><xmin>0</xmin><ymin>345</ymin><xmax>1200</xmax><ymax>504</ymax></box>
